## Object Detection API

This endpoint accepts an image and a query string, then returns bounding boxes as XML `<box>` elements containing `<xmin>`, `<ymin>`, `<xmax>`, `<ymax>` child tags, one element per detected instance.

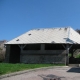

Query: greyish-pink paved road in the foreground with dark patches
<box><xmin>0</xmin><ymin>67</ymin><xmax>80</xmax><ymax>80</ymax></box>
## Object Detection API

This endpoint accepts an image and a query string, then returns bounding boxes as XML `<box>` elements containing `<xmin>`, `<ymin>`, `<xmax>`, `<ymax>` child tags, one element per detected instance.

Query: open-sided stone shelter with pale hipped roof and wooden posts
<box><xmin>5</xmin><ymin>27</ymin><xmax>80</xmax><ymax>65</ymax></box>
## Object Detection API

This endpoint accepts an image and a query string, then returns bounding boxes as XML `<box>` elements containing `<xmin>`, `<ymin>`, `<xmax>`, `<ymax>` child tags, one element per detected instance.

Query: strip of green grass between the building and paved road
<box><xmin>0</xmin><ymin>63</ymin><xmax>64</xmax><ymax>75</ymax></box>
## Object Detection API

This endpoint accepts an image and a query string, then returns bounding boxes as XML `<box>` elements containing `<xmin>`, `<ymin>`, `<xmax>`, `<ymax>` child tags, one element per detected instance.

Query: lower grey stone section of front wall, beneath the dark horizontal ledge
<box><xmin>20</xmin><ymin>55</ymin><xmax>65</xmax><ymax>63</ymax></box>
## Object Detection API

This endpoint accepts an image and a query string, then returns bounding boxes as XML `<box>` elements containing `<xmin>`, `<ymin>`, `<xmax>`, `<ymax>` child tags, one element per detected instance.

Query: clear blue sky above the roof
<box><xmin>0</xmin><ymin>0</ymin><xmax>80</xmax><ymax>41</ymax></box>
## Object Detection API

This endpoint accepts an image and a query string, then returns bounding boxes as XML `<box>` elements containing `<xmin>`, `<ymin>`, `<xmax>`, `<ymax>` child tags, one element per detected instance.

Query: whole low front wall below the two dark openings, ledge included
<box><xmin>20</xmin><ymin>50</ymin><xmax>65</xmax><ymax>63</ymax></box>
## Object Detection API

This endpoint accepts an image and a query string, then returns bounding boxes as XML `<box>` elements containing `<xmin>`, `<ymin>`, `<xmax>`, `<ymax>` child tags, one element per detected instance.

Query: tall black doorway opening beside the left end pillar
<box><xmin>9</xmin><ymin>45</ymin><xmax>20</xmax><ymax>63</ymax></box>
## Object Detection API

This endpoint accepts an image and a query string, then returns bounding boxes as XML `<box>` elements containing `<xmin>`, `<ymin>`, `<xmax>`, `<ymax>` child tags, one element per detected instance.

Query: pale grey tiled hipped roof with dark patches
<box><xmin>6</xmin><ymin>27</ymin><xmax>80</xmax><ymax>44</ymax></box>
